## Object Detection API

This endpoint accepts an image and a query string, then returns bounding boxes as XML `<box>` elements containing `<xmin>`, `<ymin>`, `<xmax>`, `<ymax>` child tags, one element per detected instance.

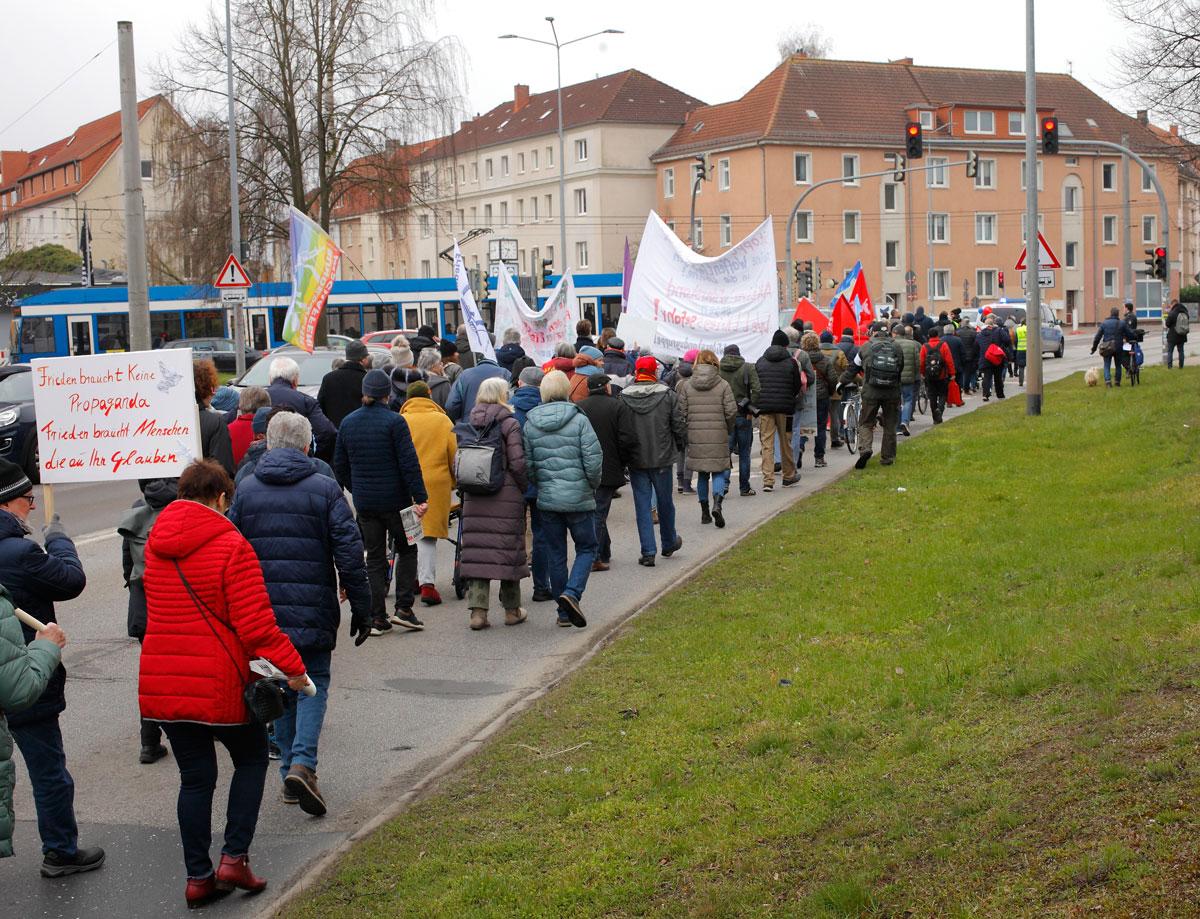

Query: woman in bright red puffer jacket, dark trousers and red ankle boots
<box><xmin>138</xmin><ymin>460</ymin><xmax>306</xmax><ymax>907</ymax></box>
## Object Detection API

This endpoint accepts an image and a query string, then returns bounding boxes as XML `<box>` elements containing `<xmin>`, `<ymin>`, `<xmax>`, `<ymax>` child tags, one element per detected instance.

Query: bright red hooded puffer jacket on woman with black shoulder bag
<box><xmin>138</xmin><ymin>500</ymin><xmax>305</xmax><ymax>725</ymax></box>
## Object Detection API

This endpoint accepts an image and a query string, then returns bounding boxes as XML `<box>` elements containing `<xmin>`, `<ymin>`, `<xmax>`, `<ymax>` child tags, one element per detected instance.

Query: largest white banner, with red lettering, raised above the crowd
<box><xmin>617</xmin><ymin>211</ymin><xmax>779</xmax><ymax>361</ymax></box>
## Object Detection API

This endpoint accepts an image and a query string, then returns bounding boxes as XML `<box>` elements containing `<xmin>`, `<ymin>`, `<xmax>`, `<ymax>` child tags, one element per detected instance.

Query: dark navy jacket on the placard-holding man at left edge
<box><xmin>0</xmin><ymin>511</ymin><xmax>88</xmax><ymax>727</ymax></box>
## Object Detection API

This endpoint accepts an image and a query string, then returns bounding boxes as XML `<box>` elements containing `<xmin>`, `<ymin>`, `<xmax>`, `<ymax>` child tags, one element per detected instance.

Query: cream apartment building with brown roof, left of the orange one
<box><xmin>403</xmin><ymin>70</ymin><xmax>702</xmax><ymax>277</ymax></box>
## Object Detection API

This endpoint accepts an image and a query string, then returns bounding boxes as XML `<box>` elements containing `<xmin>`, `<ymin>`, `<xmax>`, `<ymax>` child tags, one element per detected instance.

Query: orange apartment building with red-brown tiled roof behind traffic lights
<box><xmin>652</xmin><ymin>54</ymin><xmax>1200</xmax><ymax>323</ymax></box>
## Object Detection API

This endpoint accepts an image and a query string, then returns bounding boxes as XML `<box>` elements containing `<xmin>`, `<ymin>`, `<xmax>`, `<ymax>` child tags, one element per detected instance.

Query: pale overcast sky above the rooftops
<box><xmin>0</xmin><ymin>0</ymin><xmax>1136</xmax><ymax>149</ymax></box>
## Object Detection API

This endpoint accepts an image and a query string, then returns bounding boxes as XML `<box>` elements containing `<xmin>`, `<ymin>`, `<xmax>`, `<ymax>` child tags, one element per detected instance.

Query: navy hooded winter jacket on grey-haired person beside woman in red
<box><xmin>229</xmin><ymin>448</ymin><xmax>371</xmax><ymax>651</ymax></box>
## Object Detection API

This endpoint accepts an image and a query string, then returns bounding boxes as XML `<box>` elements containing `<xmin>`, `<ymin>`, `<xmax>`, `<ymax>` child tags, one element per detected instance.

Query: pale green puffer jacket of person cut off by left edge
<box><xmin>0</xmin><ymin>587</ymin><xmax>61</xmax><ymax>858</ymax></box>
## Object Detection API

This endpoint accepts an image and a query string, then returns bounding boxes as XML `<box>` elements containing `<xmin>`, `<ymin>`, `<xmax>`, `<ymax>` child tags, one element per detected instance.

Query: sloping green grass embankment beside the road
<box><xmin>288</xmin><ymin>370</ymin><xmax>1200</xmax><ymax>919</ymax></box>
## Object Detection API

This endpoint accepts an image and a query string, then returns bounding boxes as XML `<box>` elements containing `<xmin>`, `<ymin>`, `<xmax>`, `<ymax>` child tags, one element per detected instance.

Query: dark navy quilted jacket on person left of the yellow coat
<box><xmin>334</xmin><ymin>402</ymin><xmax>428</xmax><ymax>513</ymax></box>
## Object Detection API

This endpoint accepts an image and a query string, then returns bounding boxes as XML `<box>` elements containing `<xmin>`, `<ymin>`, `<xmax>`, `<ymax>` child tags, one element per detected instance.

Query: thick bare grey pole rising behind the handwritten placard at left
<box><xmin>116</xmin><ymin>22</ymin><xmax>150</xmax><ymax>352</ymax></box>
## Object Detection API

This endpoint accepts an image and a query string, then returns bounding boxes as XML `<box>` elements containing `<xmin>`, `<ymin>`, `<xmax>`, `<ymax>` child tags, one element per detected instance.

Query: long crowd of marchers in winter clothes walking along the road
<box><xmin>0</xmin><ymin>308</ymin><xmax>1188</xmax><ymax>906</ymax></box>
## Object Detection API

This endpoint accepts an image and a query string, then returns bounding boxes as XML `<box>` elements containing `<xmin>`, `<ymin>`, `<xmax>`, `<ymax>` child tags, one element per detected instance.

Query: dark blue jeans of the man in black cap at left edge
<box><xmin>10</xmin><ymin>715</ymin><xmax>79</xmax><ymax>857</ymax></box>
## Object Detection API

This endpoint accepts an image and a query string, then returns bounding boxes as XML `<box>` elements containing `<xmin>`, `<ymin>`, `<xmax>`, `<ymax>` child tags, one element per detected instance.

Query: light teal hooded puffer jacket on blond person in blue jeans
<box><xmin>524</xmin><ymin>402</ymin><xmax>604</xmax><ymax>513</ymax></box>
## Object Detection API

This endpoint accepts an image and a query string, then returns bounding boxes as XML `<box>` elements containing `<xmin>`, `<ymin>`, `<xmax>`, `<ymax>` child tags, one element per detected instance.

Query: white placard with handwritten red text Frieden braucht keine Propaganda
<box><xmin>31</xmin><ymin>348</ymin><xmax>200</xmax><ymax>485</ymax></box>
